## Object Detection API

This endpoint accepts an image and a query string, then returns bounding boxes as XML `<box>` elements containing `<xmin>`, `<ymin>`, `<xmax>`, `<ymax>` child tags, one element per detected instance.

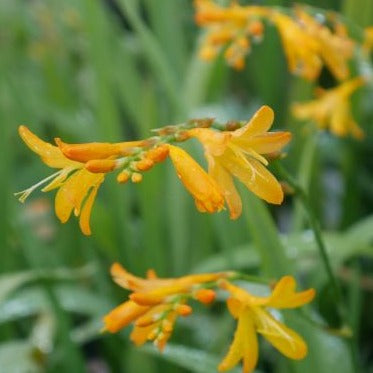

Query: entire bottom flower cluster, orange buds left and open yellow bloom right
<box><xmin>103</xmin><ymin>263</ymin><xmax>315</xmax><ymax>373</ymax></box>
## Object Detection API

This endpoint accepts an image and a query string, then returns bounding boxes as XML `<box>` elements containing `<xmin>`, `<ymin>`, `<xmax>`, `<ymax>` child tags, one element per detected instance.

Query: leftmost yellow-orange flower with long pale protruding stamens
<box><xmin>16</xmin><ymin>126</ymin><xmax>104</xmax><ymax>235</ymax></box>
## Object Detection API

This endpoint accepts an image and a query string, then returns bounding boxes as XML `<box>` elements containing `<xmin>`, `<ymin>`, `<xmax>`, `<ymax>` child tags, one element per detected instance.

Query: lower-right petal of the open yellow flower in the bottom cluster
<box><xmin>251</xmin><ymin>307</ymin><xmax>307</xmax><ymax>360</ymax></box>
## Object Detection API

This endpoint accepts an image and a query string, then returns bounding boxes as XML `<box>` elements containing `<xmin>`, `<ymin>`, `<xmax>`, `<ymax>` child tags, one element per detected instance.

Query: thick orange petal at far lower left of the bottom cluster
<box><xmin>103</xmin><ymin>300</ymin><xmax>149</xmax><ymax>333</ymax></box>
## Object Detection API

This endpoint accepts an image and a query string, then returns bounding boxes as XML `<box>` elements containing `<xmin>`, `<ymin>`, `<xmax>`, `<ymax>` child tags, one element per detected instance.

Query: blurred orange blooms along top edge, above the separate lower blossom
<box><xmin>195</xmin><ymin>0</ymin><xmax>354</xmax><ymax>80</ymax></box>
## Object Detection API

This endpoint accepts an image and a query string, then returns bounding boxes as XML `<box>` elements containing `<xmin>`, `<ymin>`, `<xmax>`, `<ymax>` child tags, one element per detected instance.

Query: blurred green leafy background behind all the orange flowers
<box><xmin>0</xmin><ymin>0</ymin><xmax>373</xmax><ymax>373</ymax></box>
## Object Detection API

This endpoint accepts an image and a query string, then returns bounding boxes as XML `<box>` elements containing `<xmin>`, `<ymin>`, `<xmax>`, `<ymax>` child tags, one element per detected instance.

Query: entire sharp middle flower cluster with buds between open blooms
<box><xmin>16</xmin><ymin>106</ymin><xmax>291</xmax><ymax>235</ymax></box>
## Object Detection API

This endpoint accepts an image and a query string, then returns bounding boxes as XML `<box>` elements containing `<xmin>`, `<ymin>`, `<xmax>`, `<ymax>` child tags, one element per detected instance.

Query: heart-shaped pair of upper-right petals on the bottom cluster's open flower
<box><xmin>266</xmin><ymin>276</ymin><xmax>315</xmax><ymax>308</ymax></box>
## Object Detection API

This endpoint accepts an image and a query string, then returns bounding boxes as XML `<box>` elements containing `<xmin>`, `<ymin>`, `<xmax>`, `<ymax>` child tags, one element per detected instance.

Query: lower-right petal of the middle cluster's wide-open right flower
<box><xmin>217</xmin><ymin>149</ymin><xmax>284</xmax><ymax>204</ymax></box>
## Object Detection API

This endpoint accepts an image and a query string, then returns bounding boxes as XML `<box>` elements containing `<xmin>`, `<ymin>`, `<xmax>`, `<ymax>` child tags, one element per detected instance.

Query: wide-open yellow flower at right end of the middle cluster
<box><xmin>189</xmin><ymin>106</ymin><xmax>291</xmax><ymax>219</ymax></box>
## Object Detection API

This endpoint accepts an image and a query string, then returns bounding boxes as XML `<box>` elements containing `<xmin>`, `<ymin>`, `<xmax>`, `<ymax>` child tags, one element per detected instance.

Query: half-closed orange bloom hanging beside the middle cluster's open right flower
<box><xmin>168</xmin><ymin>145</ymin><xmax>224</xmax><ymax>213</ymax></box>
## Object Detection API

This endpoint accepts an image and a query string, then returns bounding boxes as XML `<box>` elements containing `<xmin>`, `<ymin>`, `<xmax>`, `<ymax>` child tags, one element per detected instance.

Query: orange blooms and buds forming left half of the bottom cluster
<box><xmin>103</xmin><ymin>263</ymin><xmax>229</xmax><ymax>350</ymax></box>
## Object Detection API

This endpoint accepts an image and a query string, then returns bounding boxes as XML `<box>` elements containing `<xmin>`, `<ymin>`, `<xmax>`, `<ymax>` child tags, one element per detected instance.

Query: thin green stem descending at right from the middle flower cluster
<box><xmin>276</xmin><ymin>162</ymin><xmax>342</xmax><ymax>304</ymax></box>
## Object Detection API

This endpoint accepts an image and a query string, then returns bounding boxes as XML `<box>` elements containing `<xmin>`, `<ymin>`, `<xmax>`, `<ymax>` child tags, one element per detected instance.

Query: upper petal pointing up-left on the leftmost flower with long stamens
<box><xmin>18</xmin><ymin>126</ymin><xmax>82</xmax><ymax>168</ymax></box>
